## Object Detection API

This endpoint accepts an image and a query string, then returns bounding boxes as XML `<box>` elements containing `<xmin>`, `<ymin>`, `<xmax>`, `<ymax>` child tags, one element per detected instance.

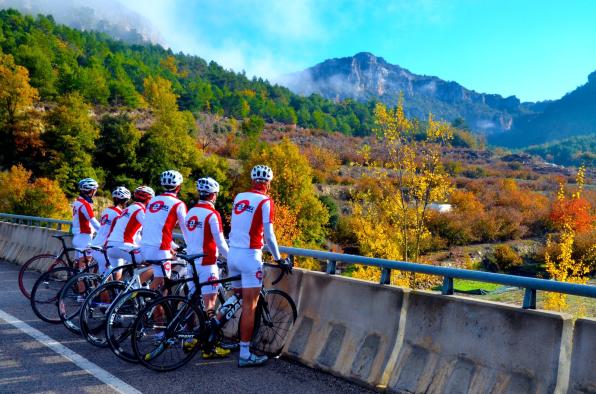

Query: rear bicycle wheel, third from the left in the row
<box><xmin>58</xmin><ymin>272</ymin><xmax>102</xmax><ymax>335</ymax></box>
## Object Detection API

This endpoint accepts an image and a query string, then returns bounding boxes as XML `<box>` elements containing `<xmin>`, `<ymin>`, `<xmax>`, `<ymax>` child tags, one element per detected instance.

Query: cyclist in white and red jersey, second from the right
<box><xmin>184</xmin><ymin>178</ymin><xmax>230</xmax><ymax>359</ymax></box>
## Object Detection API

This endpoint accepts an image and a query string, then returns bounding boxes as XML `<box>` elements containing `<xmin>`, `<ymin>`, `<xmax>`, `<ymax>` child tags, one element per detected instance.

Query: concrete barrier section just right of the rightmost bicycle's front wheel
<box><xmin>284</xmin><ymin>271</ymin><xmax>404</xmax><ymax>386</ymax></box>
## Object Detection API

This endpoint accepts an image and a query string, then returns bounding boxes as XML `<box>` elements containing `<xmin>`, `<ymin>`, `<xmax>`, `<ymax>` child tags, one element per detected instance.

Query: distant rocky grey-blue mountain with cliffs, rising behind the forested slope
<box><xmin>282</xmin><ymin>52</ymin><xmax>543</xmax><ymax>134</ymax></box>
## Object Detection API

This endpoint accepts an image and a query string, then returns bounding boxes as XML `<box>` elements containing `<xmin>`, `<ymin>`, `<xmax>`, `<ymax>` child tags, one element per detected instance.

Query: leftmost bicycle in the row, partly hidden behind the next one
<box><xmin>18</xmin><ymin>234</ymin><xmax>75</xmax><ymax>299</ymax></box>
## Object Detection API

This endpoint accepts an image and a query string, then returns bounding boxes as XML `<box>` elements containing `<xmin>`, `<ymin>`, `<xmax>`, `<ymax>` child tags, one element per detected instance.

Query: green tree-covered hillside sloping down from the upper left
<box><xmin>0</xmin><ymin>10</ymin><xmax>374</xmax><ymax>135</ymax></box>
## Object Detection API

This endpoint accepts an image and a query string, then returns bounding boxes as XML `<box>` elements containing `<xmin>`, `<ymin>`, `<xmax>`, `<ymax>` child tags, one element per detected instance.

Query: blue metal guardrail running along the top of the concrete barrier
<box><xmin>0</xmin><ymin>213</ymin><xmax>596</xmax><ymax>309</ymax></box>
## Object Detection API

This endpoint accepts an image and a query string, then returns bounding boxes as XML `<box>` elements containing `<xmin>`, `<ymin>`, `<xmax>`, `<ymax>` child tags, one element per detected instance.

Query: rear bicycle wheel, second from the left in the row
<box><xmin>29</xmin><ymin>267</ymin><xmax>78</xmax><ymax>324</ymax></box>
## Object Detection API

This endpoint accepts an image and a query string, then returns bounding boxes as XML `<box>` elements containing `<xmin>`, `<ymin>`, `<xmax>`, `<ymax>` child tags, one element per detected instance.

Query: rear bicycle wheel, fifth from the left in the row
<box><xmin>106</xmin><ymin>289</ymin><xmax>161</xmax><ymax>363</ymax></box>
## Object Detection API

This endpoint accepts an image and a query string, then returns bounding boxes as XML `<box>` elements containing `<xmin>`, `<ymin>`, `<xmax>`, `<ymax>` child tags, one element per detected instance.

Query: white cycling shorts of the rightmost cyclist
<box><xmin>228</xmin><ymin>248</ymin><xmax>263</xmax><ymax>289</ymax></box>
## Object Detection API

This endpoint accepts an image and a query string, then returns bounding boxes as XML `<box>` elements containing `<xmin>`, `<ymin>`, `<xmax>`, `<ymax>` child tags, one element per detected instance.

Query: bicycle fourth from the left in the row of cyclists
<box><xmin>79</xmin><ymin>248</ymin><xmax>182</xmax><ymax>347</ymax></box>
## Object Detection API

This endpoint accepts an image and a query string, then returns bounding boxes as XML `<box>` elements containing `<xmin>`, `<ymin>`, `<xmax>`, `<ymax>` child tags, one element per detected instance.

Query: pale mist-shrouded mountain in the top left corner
<box><xmin>0</xmin><ymin>0</ymin><xmax>164</xmax><ymax>45</ymax></box>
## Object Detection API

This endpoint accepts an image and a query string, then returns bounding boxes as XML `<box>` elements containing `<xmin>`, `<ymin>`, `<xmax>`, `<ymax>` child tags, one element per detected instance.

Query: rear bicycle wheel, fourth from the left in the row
<box><xmin>79</xmin><ymin>281</ymin><xmax>126</xmax><ymax>347</ymax></box>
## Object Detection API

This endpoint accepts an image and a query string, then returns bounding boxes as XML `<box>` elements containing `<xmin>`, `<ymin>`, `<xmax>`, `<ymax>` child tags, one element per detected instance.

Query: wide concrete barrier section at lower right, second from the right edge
<box><xmin>388</xmin><ymin>291</ymin><xmax>572</xmax><ymax>393</ymax></box>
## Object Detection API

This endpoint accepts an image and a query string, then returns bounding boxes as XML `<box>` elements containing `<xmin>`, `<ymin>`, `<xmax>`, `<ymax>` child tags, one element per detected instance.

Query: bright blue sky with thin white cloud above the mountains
<box><xmin>121</xmin><ymin>0</ymin><xmax>596</xmax><ymax>101</ymax></box>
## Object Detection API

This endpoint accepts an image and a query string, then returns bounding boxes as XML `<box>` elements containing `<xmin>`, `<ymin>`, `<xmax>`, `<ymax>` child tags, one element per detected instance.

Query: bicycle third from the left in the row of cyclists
<box><xmin>58</xmin><ymin>246</ymin><xmax>133</xmax><ymax>335</ymax></box>
